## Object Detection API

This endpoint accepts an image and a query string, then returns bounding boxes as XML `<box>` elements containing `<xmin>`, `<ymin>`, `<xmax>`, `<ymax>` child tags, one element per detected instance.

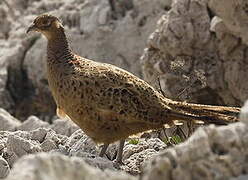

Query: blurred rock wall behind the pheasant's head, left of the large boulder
<box><xmin>0</xmin><ymin>0</ymin><xmax>171</xmax><ymax>119</ymax></box>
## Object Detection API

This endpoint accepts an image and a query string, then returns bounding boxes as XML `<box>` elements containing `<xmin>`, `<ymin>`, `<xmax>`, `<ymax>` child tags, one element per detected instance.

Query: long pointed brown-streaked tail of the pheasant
<box><xmin>167</xmin><ymin>101</ymin><xmax>240</xmax><ymax>125</ymax></box>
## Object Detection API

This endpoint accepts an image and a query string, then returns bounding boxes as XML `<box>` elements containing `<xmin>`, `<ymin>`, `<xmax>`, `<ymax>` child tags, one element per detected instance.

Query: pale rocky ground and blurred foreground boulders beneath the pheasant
<box><xmin>0</xmin><ymin>102</ymin><xmax>248</xmax><ymax>180</ymax></box>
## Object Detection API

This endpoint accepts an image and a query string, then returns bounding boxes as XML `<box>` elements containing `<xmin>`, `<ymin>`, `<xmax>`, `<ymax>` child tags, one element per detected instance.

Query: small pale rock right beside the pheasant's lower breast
<box><xmin>51</xmin><ymin>118</ymin><xmax>79</xmax><ymax>137</ymax></box>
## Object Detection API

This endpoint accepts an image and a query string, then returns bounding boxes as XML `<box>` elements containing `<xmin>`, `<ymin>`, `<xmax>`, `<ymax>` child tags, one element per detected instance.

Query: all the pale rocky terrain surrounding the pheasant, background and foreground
<box><xmin>0</xmin><ymin>0</ymin><xmax>248</xmax><ymax>180</ymax></box>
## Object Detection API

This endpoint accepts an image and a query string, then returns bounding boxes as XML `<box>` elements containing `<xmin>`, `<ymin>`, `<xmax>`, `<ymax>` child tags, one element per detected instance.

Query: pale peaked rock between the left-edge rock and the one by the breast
<box><xmin>17</xmin><ymin>116</ymin><xmax>49</xmax><ymax>131</ymax></box>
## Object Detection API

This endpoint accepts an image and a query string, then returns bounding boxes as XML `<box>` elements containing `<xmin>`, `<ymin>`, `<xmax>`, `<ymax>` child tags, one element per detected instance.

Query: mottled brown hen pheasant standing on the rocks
<box><xmin>27</xmin><ymin>14</ymin><xmax>240</xmax><ymax>162</ymax></box>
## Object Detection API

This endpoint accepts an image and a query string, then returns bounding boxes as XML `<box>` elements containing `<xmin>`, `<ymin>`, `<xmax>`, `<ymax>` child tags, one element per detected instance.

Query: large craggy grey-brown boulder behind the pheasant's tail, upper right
<box><xmin>141</xmin><ymin>0</ymin><xmax>248</xmax><ymax>106</ymax></box>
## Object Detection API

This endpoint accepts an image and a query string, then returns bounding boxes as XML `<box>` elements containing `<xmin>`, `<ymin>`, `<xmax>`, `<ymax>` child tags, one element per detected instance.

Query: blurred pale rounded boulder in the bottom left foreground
<box><xmin>6</xmin><ymin>153</ymin><xmax>137</xmax><ymax>180</ymax></box>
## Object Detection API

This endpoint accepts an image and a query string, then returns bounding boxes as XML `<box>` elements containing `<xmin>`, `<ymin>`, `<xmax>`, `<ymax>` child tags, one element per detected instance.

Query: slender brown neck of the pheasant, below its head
<box><xmin>47</xmin><ymin>28</ymin><xmax>74</xmax><ymax>63</ymax></box>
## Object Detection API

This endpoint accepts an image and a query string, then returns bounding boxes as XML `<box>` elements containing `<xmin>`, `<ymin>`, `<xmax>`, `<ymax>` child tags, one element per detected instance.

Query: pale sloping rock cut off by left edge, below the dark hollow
<box><xmin>0</xmin><ymin>108</ymin><xmax>21</xmax><ymax>131</ymax></box>
